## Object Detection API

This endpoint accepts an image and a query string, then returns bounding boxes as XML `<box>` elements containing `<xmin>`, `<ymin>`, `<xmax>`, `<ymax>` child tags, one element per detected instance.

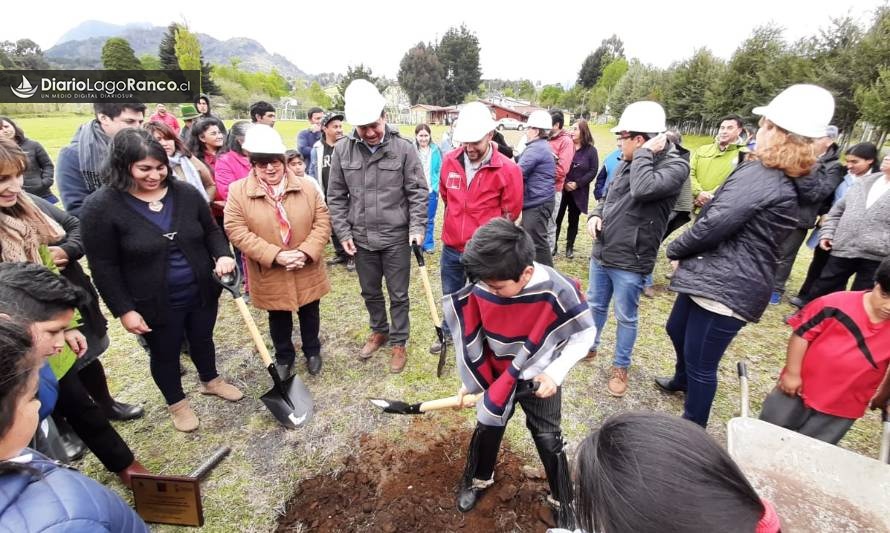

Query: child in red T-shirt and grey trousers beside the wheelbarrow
<box><xmin>760</xmin><ymin>258</ymin><xmax>890</xmax><ymax>444</ymax></box>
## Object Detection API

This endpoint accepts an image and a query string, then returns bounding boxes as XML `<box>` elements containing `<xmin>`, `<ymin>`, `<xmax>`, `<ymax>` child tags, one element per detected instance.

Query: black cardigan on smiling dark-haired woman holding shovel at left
<box><xmin>80</xmin><ymin>178</ymin><xmax>232</xmax><ymax>327</ymax></box>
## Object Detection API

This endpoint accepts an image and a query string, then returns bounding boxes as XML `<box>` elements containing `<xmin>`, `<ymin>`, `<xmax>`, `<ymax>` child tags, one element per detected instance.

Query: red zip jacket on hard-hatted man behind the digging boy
<box><xmin>439</xmin><ymin>145</ymin><xmax>522</xmax><ymax>252</ymax></box>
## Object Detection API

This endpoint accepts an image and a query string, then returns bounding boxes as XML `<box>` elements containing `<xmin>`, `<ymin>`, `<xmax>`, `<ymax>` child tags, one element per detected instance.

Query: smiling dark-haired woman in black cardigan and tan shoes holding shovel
<box><xmin>81</xmin><ymin>129</ymin><xmax>243</xmax><ymax>431</ymax></box>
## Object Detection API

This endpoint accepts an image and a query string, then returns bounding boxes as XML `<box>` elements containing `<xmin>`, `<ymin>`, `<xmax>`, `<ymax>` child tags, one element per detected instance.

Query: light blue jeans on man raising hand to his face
<box><xmin>587</xmin><ymin>258</ymin><xmax>644</xmax><ymax>368</ymax></box>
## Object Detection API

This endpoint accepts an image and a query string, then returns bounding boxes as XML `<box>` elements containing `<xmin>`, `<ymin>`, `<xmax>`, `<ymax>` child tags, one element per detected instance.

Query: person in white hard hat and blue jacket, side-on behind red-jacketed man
<box><xmin>519</xmin><ymin>109</ymin><xmax>556</xmax><ymax>266</ymax></box>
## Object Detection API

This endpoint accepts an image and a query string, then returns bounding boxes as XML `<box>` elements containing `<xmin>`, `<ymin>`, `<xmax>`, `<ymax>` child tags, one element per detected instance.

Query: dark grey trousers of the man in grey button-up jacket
<box><xmin>355</xmin><ymin>244</ymin><xmax>411</xmax><ymax>346</ymax></box>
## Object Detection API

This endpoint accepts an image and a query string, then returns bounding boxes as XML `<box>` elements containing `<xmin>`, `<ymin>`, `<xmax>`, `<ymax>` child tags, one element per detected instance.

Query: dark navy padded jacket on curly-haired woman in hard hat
<box><xmin>667</xmin><ymin>161</ymin><xmax>798</xmax><ymax>322</ymax></box>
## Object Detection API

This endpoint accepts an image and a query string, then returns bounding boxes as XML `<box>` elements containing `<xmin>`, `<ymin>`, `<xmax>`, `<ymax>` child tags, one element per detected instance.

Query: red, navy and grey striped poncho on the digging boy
<box><xmin>444</xmin><ymin>264</ymin><xmax>593</xmax><ymax>426</ymax></box>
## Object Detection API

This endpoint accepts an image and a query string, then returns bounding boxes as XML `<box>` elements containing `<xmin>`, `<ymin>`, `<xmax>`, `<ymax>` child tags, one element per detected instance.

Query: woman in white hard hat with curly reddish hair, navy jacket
<box><xmin>655</xmin><ymin>85</ymin><xmax>834</xmax><ymax>427</ymax></box>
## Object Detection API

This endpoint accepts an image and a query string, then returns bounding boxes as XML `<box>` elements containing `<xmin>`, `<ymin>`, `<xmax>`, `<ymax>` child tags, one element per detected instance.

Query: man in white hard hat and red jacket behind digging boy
<box><xmin>430</xmin><ymin>102</ymin><xmax>522</xmax><ymax>353</ymax></box>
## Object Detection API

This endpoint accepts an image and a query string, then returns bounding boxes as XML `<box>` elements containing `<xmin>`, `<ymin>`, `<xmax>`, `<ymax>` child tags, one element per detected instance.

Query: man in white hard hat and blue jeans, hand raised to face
<box><xmin>587</xmin><ymin>101</ymin><xmax>689</xmax><ymax>397</ymax></box>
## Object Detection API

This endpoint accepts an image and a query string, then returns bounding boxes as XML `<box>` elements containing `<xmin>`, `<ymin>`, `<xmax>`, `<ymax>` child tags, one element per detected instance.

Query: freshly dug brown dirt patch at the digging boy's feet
<box><xmin>277</xmin><ymin>415</ymin><xmax>553</xmax><ymax>533</ymax></box>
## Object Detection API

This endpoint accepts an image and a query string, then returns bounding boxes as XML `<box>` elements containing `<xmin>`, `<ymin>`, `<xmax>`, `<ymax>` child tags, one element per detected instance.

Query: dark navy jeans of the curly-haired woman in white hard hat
<box><xmin>665</xmin><ymin>294</ymin><xmax>745</xmax><ymax>427</ymax></box>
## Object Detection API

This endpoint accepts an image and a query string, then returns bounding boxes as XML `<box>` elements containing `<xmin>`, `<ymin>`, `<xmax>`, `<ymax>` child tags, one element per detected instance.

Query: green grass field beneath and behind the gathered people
<box><xmin>12</xmin><ymin>116</ymin><xmax>880</xmax><ymax>532</ymax></box>
